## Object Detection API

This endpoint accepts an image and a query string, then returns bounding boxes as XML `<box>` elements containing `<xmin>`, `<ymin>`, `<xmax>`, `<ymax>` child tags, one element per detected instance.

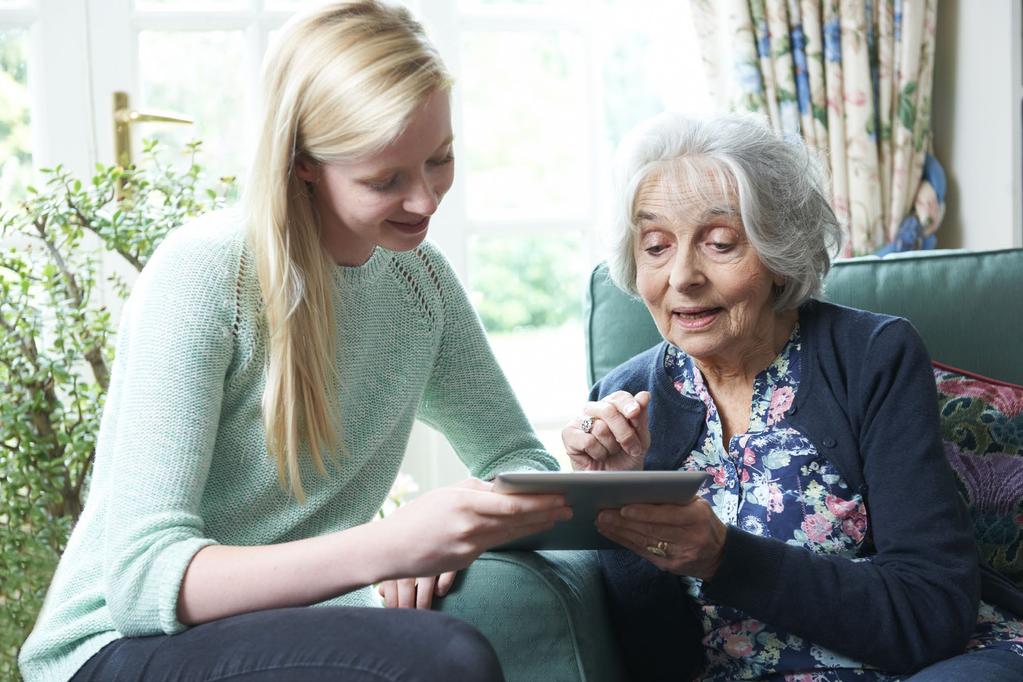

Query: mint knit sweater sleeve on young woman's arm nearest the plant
<box><xmin>97</xmin><ymin>221</ymin><xmax>238</xmax><ymax>637</ymax></box>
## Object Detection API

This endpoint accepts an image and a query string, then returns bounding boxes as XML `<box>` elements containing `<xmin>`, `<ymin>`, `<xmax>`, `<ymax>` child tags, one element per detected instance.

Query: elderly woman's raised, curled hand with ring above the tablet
<box><xmin>562</xmin><ymin>391</ymin><xmax>650</xmax><ymax>471</ymax></box>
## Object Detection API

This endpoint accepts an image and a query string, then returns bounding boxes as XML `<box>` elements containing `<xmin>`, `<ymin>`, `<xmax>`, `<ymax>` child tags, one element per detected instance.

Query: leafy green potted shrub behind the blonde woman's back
<box><xmin>0</xmin><ymin>141</ymin><xmax>235</xmax><ymax>680</ymax></box>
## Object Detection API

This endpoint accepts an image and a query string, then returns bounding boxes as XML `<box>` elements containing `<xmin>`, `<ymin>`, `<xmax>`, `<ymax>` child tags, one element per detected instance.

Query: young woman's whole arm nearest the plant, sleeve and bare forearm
<box><xmin>97</xmin><ymin>221</ymin><xmax>564</xmax><ymax>637</ymax></box>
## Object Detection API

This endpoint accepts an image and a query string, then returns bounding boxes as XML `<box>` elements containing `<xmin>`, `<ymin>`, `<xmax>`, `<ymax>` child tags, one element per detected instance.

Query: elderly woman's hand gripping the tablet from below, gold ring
<box><xmin>596</xmin><ymin>499</ymin><xmax>726</xmax><ymax>580</ymax></box>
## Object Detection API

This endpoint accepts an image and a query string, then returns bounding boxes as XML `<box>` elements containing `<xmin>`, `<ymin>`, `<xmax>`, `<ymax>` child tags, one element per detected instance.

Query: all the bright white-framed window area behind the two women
<box><xmin>0</xmin><ymin>0</ymin><xmax>710</xmax><ymax>488</ymax></box>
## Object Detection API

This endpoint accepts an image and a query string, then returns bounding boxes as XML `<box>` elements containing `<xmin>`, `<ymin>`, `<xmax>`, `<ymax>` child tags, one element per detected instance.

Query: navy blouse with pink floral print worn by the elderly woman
<box><xmin>664</xmin><ymin>325</ymin><xmax>1023</xmax><ymax>682</ymax></box>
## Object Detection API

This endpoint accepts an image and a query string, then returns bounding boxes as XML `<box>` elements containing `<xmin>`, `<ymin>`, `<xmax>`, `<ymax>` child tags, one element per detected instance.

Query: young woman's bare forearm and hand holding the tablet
<box><xmin>178</xmin><ymin>479</ymin><xmax>571</xmax><ymax>625</ymax></box>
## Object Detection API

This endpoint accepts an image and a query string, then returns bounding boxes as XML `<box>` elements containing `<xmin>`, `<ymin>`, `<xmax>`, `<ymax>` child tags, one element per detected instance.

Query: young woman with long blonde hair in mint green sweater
<box><xmin>19</xmin><ymin>0</ymin><xmax>571</xmax><ymax>682</ymax></box>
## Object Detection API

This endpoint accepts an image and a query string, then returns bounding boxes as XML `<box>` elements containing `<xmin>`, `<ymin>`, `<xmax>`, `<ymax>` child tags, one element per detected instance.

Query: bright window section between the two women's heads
<box><xmin>422</xmin><ymin>0</ymin><xmax>711</xmax><ymax>465</ymax></box>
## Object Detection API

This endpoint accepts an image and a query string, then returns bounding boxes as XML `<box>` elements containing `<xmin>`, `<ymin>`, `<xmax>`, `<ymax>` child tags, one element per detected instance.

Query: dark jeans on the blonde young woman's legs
<box><xmin>72</xmin><ymin>606</ymin><xmax>504</xmax><ymax>682</ymax></box>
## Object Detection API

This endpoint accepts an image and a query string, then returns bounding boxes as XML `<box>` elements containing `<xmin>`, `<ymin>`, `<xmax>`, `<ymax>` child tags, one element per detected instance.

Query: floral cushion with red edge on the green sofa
<box><xmin>934</xmin><ymin>362</ymin><xmax>1023</xmax><ymax>586</ymax></box>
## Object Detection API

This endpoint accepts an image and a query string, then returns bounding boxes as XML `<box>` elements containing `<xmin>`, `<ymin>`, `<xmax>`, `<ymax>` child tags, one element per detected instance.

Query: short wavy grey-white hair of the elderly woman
<box><xmin>608</xmin><ymin>113</ymin><xmax>843</xmax><ymax>311</ymax></box>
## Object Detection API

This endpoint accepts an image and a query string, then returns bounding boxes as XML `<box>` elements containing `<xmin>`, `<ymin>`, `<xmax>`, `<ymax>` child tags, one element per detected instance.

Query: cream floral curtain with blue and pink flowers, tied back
<box><xmin>691</xmin><ymin>0</ymin><xmax>945</xmax><ymax>255</ymax></box>
